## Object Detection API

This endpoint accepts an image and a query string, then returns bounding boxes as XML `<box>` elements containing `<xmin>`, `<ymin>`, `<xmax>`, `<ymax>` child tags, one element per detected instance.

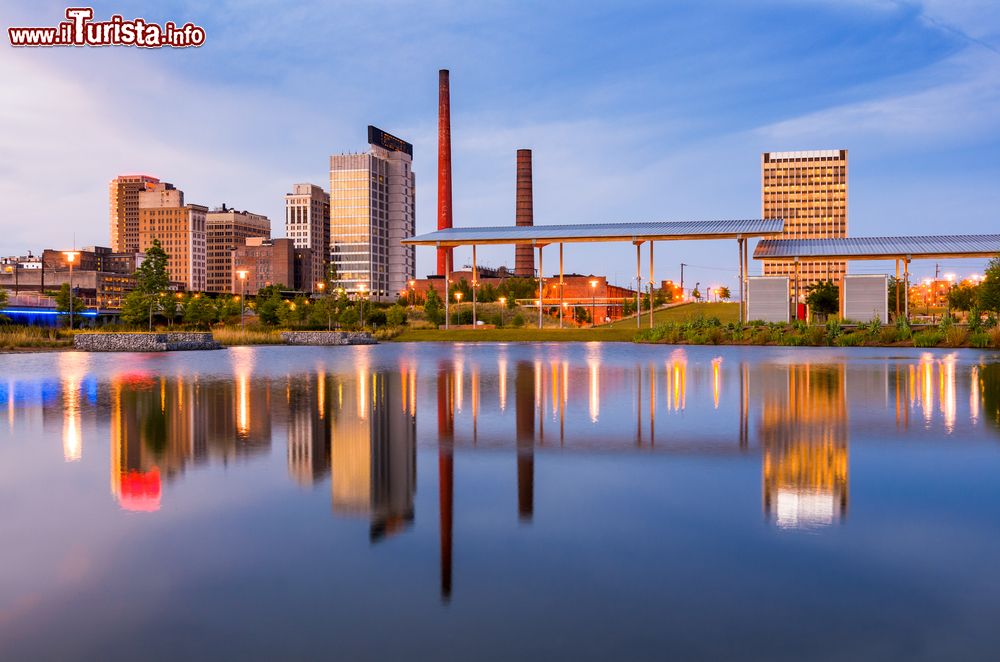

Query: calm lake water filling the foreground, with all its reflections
<box><xmin>0</xmin><ymin>343</ymin><xmax>1000</xmax><ymax>660</ymax></box>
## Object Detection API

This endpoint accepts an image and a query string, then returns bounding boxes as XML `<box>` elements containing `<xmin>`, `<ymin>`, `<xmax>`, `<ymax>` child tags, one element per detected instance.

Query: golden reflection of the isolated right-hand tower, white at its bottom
<box><xmin>753</xmin><ymin>364</ymin><xmax>848</xmax><ymax>528</ymax></box>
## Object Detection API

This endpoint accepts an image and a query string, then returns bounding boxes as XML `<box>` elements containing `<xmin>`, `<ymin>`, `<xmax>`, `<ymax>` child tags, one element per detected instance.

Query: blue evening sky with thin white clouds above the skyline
<box><xmin>0</xmin><ymin>0</ymin><xmax>1000</xmax><ymax>286</ymax></box>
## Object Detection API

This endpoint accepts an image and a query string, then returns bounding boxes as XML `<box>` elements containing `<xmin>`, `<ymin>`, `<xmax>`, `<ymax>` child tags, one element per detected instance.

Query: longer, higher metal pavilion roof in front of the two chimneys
<box><xmin>403</xmin><ymin>219</ymin><xmax>785</xmax><ymax>246</ymax></box>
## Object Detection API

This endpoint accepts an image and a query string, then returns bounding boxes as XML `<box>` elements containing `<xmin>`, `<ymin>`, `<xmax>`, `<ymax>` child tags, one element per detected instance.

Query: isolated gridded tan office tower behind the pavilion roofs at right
<box><xmin>761</xmin><ymin>149</ymin><xmax>847</xmax><ymax>292</ymax></box>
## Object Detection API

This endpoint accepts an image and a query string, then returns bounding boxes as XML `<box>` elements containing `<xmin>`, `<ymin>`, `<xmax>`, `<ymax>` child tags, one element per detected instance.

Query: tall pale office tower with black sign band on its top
<box><xmin>330</xmin><ymin>126</ymin><xmax>416</xmax><ymax>301</ymax></box>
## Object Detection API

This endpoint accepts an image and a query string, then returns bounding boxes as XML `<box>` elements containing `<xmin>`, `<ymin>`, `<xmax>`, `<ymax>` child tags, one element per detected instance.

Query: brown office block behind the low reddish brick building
<box><xmin>205</xmin><ymin>205</ymin><xmax>271</xmax><ymax>293</ymax></box>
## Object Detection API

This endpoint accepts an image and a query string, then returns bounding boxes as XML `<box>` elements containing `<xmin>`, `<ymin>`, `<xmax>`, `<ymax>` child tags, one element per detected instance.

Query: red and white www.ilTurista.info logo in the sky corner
<box><xmin>7</xmin><ymin>7</ymin><xmax>205</xmax><ymax>48</ymax></box>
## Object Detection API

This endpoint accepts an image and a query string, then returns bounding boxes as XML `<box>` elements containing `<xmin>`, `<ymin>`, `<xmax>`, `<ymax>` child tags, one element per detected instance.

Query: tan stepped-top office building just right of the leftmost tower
<box><xmin>139</xmin><ymin>182</ymin><xmax>208</xmax><ymax>292</ymax></box>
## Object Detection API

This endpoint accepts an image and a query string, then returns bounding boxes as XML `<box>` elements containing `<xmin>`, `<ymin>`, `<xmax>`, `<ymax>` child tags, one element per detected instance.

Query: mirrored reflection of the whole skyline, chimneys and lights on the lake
<box><xmin>0</xmin><ymin>344</ymin><xmax>1000</xmax><ymax>584</ymax></box>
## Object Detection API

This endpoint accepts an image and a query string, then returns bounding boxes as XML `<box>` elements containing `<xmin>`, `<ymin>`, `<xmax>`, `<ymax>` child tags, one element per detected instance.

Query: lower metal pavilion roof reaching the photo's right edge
<box><xmin>753</xmin><ymin>234</ymin><xmax>1000</xmax><ymax>260</ymax></box>
